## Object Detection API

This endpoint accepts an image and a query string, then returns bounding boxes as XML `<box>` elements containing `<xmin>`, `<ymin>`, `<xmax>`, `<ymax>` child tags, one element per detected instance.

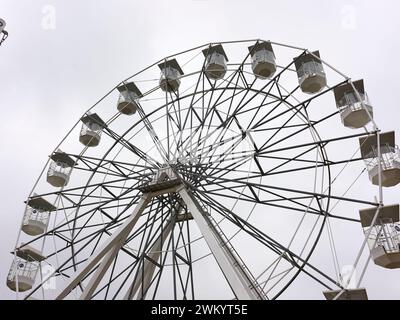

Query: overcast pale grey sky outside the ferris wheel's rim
<box><xmin>0</xmin><ymin>0</ymin><xmax>400</xmax><ymax>299</ymax></box>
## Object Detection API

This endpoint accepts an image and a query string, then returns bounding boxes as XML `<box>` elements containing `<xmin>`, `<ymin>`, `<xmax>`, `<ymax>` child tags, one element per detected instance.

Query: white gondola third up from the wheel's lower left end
<box><xmin>47</xmin><ymin>150</ymin><xmax>75</xmax><ymax>188</ymax></box>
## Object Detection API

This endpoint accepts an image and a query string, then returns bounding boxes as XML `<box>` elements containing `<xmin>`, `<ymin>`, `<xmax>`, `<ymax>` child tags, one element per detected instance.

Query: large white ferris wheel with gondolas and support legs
<box><xmin>7</xmin><ymin>39</ymin><xmax>400</xmax><ymax>300</ymax></box>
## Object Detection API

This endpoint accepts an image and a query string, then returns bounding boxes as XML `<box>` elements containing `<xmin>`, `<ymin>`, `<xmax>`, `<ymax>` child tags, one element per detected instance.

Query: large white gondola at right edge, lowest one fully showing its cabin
<box><xmin>360</xmin><ymin>204</ymin><xmax>400</xmax><ymax>269</ymax></box>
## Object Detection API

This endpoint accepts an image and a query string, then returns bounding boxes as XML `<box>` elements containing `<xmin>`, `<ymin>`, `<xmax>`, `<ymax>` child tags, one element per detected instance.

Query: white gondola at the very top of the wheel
<box><xmin>249</xmin><ymin>42</ymin><xmax>276</xmax><ymax>79</ymax></box>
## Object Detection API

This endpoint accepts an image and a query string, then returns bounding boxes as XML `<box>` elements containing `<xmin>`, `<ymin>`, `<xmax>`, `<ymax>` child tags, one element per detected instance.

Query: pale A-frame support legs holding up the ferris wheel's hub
<box><xmin>56</xmin><ymin>168</ymin><xmax>266</xmax><ymax>300</ymax></box>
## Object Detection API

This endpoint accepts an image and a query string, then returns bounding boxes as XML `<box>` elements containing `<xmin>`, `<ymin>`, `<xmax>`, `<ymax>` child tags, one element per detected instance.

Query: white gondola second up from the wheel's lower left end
<box><xmin>21</xmin><ymin>195</ymin><xmax>57</xmax><ymax>236</ymax></box>
